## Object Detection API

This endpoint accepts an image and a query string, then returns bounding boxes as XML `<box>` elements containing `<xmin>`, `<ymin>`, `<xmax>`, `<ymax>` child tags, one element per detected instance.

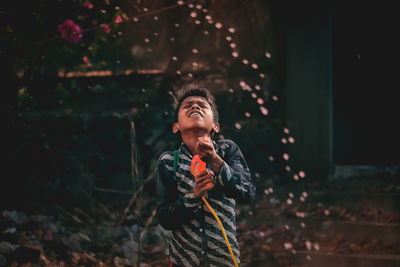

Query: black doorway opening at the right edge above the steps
<box><xmin>332</xmin><ymin>1</ymin><xmax>400</xmax><ymax>165</ymax></box>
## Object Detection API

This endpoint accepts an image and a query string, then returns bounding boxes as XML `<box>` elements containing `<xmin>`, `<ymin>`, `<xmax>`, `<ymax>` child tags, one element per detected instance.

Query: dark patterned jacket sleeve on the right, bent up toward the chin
<box><xmin>218</xmin><ymin>140</ymin><xmax>256</xmax><ymax>204</ymax></box>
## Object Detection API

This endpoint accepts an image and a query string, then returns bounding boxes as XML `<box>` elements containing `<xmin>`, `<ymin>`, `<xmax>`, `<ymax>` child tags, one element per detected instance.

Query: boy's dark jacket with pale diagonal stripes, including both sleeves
<box><xmin>156</xmin><ymin>139</ymin><xmax>255</xmax><ymax>267</ymax></box>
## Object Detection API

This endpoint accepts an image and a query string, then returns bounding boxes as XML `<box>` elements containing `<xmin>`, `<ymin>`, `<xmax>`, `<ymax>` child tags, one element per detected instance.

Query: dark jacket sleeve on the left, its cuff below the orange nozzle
<box><xmin>156</xmin><ymin>155</ymin><xmax>202</xmax><ymax>230</ymax></box>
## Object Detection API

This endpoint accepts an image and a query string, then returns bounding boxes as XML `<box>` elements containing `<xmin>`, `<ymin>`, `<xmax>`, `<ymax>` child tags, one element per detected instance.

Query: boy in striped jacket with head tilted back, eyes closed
<box><xmin>156</xmin><ymin>87</ymin><xmax>255</xmax><ymax>267</ymax></box>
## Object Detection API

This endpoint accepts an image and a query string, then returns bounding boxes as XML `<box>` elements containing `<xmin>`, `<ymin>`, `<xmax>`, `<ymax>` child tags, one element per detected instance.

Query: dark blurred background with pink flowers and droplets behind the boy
<box><xmin>0</xmin><ymin>0</ymin><xmax>400</xmax><ymax>266</ymax></box>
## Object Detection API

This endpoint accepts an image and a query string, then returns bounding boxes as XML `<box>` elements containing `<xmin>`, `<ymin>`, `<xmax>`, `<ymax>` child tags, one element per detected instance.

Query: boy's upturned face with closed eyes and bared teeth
<box><xmin>172</xmin><ymin>96</ymin><xmax>219</xmax><ymax>137</ymax></box>
